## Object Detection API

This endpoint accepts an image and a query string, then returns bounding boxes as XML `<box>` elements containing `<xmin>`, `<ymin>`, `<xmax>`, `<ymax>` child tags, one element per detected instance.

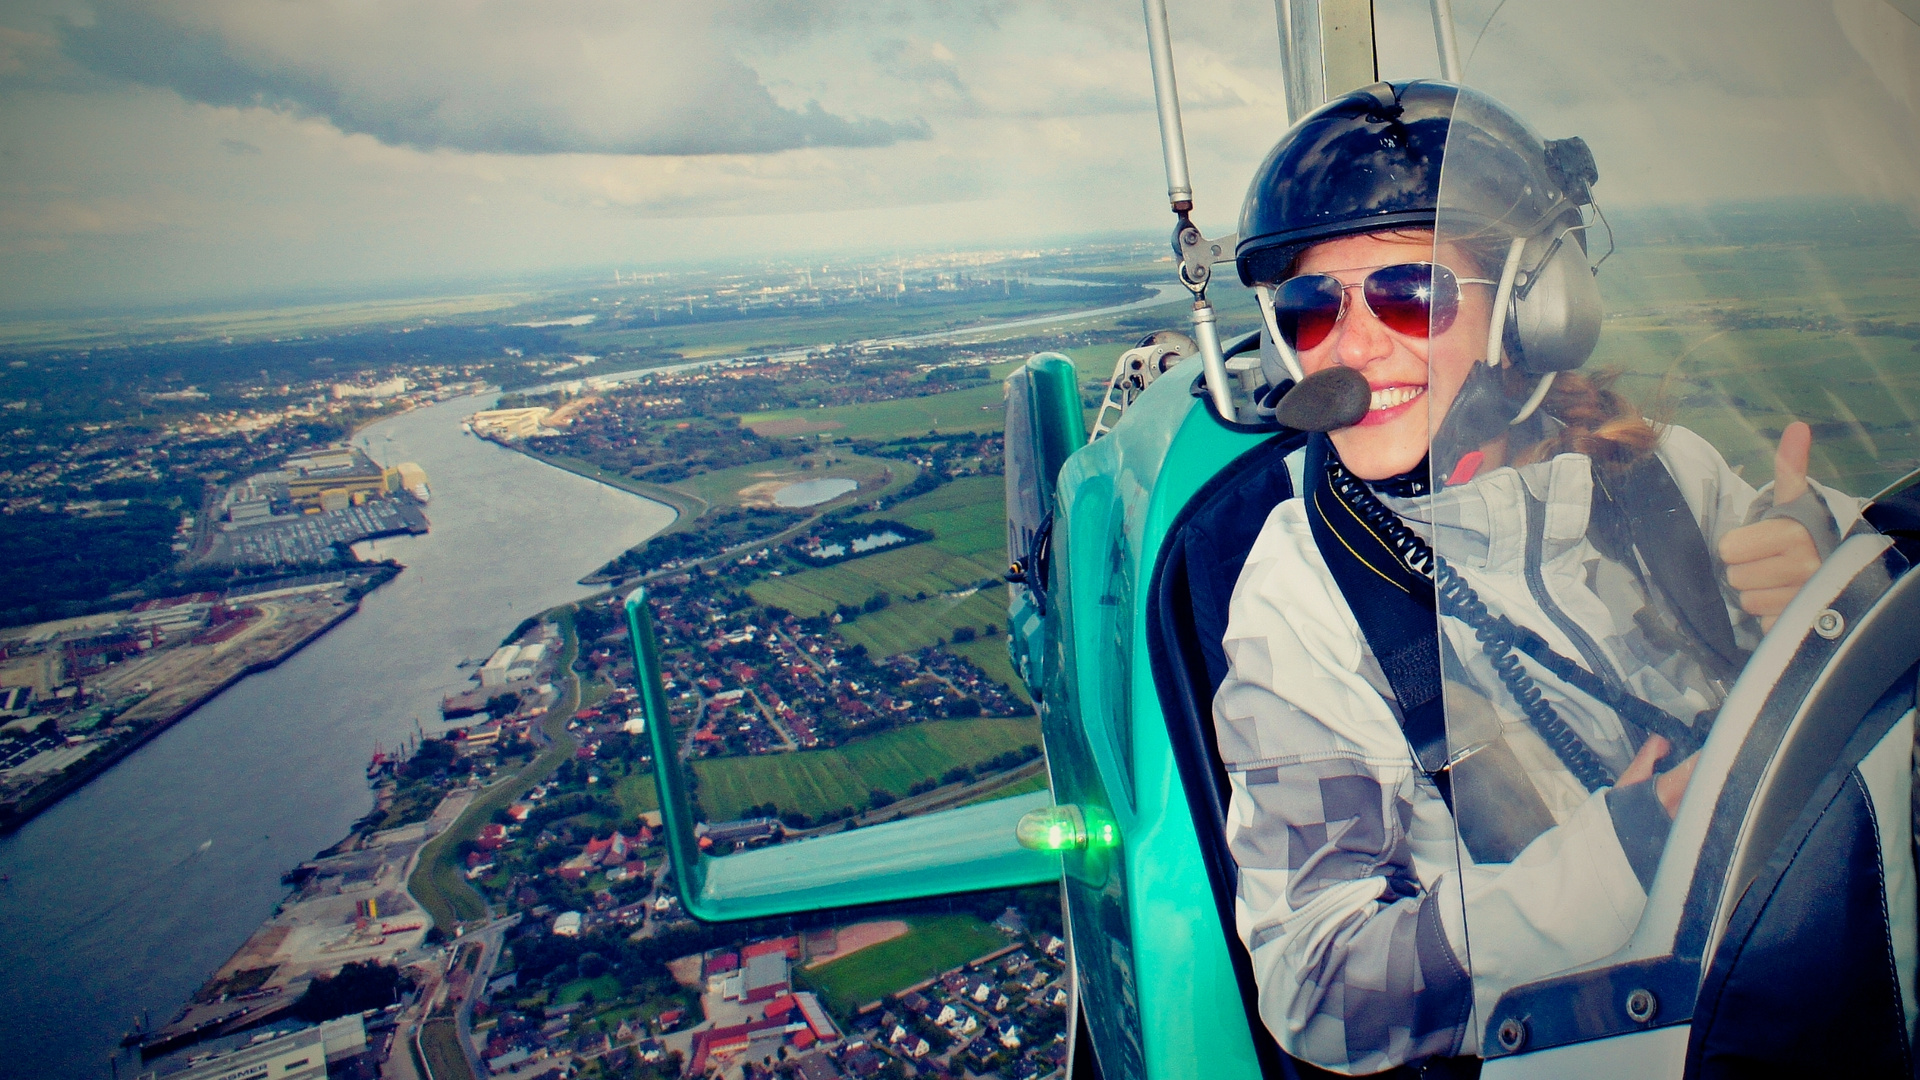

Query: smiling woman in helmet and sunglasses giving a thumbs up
<box><xmin>1213</xmin><ymin>83</ymin><xmax>1859</xmax><ymax>1074</ymax></box>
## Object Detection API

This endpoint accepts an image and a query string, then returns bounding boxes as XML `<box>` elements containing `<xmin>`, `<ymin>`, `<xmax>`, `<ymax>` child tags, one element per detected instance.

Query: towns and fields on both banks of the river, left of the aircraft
<box><xmin>0</xmin><ymin>237</ymin><xmax>1182</xmax><ymax>1080</ymax></box>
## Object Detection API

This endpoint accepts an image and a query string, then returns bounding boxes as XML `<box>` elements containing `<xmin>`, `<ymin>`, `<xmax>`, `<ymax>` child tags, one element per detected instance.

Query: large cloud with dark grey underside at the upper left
<box><xmin>61</xmin><ymin>2</ymin><xmax>929</xmax><ymax>156</ymax></box>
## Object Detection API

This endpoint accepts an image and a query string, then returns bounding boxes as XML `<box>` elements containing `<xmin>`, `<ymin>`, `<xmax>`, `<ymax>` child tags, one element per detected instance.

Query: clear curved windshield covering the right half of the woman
<box><xmin>1428</xmin><ymin>0</ymin><xmax>1920</xmax><ymax>1051</ymax></box>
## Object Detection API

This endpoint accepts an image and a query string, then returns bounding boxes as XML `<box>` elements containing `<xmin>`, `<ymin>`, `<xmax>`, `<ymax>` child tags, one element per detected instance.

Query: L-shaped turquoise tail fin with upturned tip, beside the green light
<box><xmin>626</xmin><ymin>588</ymin><xmax>1060</xmax><ymax>922</ymax></box>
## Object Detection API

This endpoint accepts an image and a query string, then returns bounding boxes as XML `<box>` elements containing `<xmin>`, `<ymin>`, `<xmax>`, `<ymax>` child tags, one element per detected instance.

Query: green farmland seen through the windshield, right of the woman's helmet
<box><xmin>1588</xmin><ymin>236</ymin><xmax>1920</xmax><ymax>496</ymax></box>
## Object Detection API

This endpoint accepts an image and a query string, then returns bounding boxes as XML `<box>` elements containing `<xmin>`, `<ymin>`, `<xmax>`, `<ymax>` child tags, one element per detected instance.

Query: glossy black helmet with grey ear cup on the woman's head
<box><xmin>1235</xmin><ymin>81</ymin><xmax>1599</xmax><ymax>373</ymax></box>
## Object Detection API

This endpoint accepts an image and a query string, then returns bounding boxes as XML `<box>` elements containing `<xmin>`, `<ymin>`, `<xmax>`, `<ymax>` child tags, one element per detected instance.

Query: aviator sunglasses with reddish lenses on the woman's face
<box><xmin>1273</xmin><ymin>263</ymin><xmax>1500</xmax><ymax>352</ymax></box>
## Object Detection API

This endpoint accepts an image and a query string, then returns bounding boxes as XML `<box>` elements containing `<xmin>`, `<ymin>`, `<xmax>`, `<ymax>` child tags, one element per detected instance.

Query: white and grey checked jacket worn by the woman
<box><xmin>1213</xmin><ymin>429</ymin><xmax>1859</xmax><ymax>1072</ymax></box>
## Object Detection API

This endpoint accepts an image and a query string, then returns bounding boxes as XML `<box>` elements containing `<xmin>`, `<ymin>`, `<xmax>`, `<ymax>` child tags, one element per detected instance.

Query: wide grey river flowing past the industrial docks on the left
<box><xmin>0</xmin><ymin>398</ymin><xmax>672</xmax><ymax>1080</ymax></box>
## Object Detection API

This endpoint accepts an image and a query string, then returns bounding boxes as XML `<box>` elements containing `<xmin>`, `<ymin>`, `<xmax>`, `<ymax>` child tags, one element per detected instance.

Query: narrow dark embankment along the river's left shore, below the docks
<box><xmin>0</xmin><ymin>567</ymin><xmax>399</xmax><ymax>834</ymax></box>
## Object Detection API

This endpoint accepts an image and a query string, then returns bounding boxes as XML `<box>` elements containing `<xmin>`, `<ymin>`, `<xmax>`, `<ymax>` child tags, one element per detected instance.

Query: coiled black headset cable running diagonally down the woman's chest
<box><xmin>1327</xmin><ymin>457</ymin><xmax>1703</xmax><ymax>792</ymax></box>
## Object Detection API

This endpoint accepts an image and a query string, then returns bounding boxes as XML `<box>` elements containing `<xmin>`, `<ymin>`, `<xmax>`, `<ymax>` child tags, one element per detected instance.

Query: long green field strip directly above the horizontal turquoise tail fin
<box><xmin>693</xmin><ymin>717</ymin><xmax>1041</xmax><ymax>821</ymax></box>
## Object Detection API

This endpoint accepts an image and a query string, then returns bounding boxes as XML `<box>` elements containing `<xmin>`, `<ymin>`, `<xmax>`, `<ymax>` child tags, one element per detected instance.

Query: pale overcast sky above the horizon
<box><xmin>0</xmin><ymin>0</ymin><xmax>1920</xmax><ymax>311</ymax></box>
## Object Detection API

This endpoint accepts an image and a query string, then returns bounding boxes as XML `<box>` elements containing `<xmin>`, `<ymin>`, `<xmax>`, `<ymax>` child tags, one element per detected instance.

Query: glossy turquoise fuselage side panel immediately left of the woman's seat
<box><xmin>1041</xmin><ymin>359</ymin><xmax>1267</xmax><ymax>1080</ymax></box>
